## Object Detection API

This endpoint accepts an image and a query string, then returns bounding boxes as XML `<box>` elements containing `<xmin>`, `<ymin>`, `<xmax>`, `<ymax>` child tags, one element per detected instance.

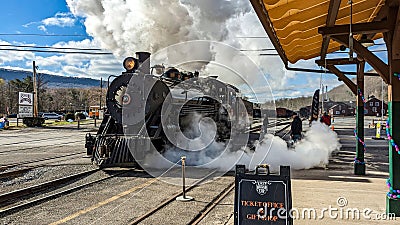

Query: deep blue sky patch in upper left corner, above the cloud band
<box><xmin>0</xmin><ymin>0</ymin><xmax>90</xmax><ymax>45</ymax></box>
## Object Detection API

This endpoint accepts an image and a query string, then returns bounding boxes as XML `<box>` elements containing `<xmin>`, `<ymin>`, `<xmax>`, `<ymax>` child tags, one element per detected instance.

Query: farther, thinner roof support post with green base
<box><xmin>354</xmin><ymin>61</ymin><xmax>365</xmax><ymax>175</ymax></box>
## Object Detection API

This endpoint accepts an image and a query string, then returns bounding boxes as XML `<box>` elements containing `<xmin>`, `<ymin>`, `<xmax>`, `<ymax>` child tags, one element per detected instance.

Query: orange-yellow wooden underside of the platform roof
<box><xmin>250</xmin><ymin>0</ymin><xmax>385</xmax><ymax>65</ymax></box>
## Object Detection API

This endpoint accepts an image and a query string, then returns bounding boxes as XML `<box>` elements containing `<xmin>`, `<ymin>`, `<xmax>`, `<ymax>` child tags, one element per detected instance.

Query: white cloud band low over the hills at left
<box><xmin>0</xmin><ymin>39</ymin><xmax>123</xmax><ymax>79</ymax></box>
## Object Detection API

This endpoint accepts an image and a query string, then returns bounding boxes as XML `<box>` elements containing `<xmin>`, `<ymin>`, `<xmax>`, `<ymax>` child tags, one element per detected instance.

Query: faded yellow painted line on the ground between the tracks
<box><xmin>50</xmin><ymin>178</ymin><xmax>157</xmax><ymax>225</ymax></box>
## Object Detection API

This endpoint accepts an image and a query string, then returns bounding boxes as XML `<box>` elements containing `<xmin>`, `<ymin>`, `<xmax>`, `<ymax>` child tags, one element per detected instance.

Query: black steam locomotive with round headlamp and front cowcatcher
<box><xmin>85</xmin><ymin>52</ymin><xmax>260</xmax><ymax>167</ymax></box>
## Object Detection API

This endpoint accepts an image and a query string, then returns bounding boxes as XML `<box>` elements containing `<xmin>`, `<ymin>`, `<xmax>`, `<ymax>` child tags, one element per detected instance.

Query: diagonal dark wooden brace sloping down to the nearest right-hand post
<box><xmin>332</xmin><ymin>35</ymin><xmax>389</xmax><ymax>84</ymax></box>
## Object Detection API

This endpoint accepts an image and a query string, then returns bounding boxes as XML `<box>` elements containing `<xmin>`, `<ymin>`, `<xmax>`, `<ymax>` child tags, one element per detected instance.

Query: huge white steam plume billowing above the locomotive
<box><xmin>67</xmin><ymin>0</ymin><xmax>293</xmax><ymax>96</ymax></box>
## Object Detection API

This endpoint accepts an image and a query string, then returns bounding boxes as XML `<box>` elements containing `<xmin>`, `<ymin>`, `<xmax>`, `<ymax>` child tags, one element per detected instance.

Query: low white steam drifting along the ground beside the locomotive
<box><xmin>145</xmin><ymin>117</ymin><xmax>341</xmax><ymax>171</ymax></box>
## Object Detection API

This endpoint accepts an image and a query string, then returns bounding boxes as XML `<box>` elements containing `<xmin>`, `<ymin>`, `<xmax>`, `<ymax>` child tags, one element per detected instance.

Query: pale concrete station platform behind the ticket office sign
<box><xmin>202</xmin><ymin>117</ymin><xmax>400</xmax><ymax>225</ymax></box>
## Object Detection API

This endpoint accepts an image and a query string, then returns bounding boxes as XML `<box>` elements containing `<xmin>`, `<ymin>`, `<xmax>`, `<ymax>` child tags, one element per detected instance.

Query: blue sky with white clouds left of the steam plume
<box><xmin>0</xmin><ymin>0</ymin><xmax>121</xmax><ymax>79</ymax></box>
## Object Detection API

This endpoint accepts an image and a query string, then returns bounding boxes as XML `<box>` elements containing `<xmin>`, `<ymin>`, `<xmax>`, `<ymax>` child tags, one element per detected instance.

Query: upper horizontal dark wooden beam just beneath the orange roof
<box><xmin>318</xmin><ymin>20</ymin><xmax>390</xmax><ymax>36</ymax></box>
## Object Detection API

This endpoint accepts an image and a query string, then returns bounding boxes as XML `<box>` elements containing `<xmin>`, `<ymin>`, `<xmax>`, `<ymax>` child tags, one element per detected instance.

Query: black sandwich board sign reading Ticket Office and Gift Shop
<box><xmin>234</xmin><ymin>165</ymin><xmax>293</xmax><ymax>225</ymax></box>
